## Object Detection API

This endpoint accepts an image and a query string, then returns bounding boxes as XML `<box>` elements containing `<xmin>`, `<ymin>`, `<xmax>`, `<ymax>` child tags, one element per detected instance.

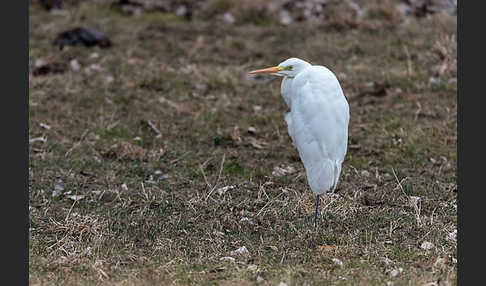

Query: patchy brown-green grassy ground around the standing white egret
<box><xmin>29</xmin><ymin>1</ymin><xmax>457</xmax><ymax>285</ymax></box>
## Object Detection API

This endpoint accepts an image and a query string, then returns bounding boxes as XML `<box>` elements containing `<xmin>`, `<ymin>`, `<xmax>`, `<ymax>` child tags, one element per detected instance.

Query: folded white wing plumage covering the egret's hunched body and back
<box><xmin>291</xmin><ymin>66</ymin><xmax>349</xmax><ymax>193</ymax></box>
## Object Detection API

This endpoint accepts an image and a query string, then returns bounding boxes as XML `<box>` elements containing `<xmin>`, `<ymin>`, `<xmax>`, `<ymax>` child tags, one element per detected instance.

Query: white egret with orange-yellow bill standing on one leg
<box><xmin>248</xmin><ymin>57</ymin><xmax>350</xmax><ymax>227</ymax></box>
